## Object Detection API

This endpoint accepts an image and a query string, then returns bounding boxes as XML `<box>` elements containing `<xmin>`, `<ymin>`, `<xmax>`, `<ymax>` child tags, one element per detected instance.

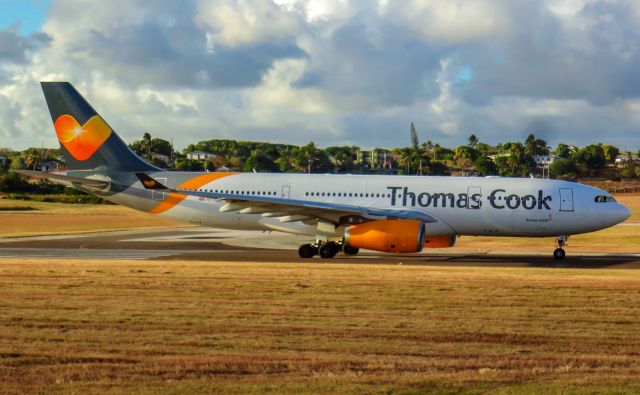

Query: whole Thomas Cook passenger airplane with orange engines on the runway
<box><xmin>18</xmin><ymin>82</ymin><xmax>631</xmax><ymax>259</ymax></box>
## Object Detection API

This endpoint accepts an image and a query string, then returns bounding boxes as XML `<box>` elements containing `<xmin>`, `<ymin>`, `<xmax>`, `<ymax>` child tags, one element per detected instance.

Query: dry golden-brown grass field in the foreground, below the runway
<box><xmin>0</xmin><ymin>260</ymin><xmax>640</xmax><ymax>394</ymax></box>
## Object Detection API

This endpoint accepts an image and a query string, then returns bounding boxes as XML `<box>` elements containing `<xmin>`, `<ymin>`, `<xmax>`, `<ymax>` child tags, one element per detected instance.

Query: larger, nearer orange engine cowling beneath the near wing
<box><xmin>344</xmin><ymin>219</ymin><xmax>425</xmax><ymax>253</ymax></box>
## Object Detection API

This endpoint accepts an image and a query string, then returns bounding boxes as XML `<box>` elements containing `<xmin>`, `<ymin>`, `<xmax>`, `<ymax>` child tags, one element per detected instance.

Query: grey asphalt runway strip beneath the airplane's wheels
<box><xmin>0</xmin><ymin>228</ymin><xmax>640</xmax><ymax>269</ymax></box>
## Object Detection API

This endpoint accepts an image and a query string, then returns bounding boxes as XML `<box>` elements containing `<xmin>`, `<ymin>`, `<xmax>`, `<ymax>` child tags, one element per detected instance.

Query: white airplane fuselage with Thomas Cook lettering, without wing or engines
<box><xmin>111</xmin><ymin>172</ymin><xmax>630</xmax><ymax>237</ymax></box>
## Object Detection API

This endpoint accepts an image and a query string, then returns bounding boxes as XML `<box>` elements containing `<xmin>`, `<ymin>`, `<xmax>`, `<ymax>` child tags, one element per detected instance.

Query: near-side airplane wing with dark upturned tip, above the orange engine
<box><xmin>136</xmin><ymin>173</ymin><xmax>438</xmax><ymax>223</ymax></box>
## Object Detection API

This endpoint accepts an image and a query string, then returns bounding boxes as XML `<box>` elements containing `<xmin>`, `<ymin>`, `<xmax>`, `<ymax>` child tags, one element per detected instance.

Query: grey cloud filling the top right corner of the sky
<box><xmin>459</xmin><ymin>1</ymin><xmax>640</xmax><ymax>105</ymax></box>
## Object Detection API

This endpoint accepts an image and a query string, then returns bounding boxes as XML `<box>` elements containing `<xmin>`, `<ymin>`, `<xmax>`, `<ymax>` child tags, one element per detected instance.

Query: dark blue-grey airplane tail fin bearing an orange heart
<box><xmin>40</xmin><ymin>82</ymin><xmax>160</xmax><ymax>171</ymax></box>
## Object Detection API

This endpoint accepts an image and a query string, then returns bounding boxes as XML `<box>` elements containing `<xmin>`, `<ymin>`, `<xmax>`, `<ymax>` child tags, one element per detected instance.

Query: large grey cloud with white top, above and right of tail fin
<box><xmin>36</xmin><ymin>1</ymin><xmax>305</xmax><ymax>89</ymax></box>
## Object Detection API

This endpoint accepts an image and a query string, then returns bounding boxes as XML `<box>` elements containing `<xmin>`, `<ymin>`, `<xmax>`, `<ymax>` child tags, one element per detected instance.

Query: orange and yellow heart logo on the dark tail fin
<box><xmin>53</xmin><ymin>114</ymin><xmax>111</xmax><ymax>160</ymax></box>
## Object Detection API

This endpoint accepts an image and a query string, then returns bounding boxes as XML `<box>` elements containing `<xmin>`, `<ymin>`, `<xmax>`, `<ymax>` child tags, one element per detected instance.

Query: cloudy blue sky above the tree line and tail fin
<box><xmin>0</xmin><ymin>0</ymin><xmax>640</xmax><ymax>151</ymax></box>
